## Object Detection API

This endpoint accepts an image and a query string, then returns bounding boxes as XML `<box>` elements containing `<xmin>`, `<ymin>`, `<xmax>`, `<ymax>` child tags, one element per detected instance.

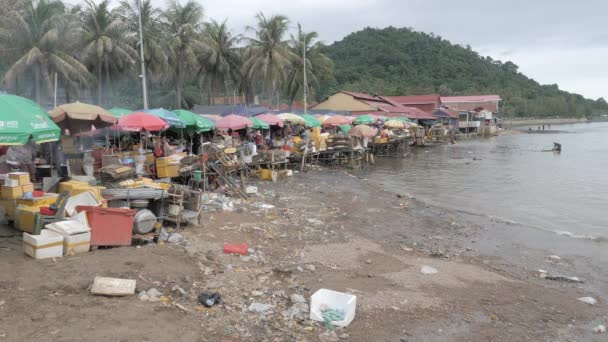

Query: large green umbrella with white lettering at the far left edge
<box><xmin>0</xmin><ymin>94</ymin><xmax>61</xmax><ymax>145</ymax></box>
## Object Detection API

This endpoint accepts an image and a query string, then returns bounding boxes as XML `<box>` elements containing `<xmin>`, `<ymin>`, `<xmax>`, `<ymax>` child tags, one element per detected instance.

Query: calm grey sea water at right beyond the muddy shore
<box><xmin>367</xmin><ymin>122</ymin><xmax>608</xmax><ymax>237</ymax></box>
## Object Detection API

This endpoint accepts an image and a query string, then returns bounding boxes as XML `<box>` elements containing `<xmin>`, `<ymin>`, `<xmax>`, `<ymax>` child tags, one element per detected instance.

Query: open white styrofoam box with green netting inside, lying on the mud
<box><xmin>310</xmin><ymin>289</ymin><xmax>357</xmax><ymax>327</ymax></box>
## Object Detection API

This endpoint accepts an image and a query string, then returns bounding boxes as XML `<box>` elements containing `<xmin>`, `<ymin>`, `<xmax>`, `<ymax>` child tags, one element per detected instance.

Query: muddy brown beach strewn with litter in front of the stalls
<box><xmin>0</xmin><ymin>168</ymin><xmax>606</xmax><ymax>341</ymax></box>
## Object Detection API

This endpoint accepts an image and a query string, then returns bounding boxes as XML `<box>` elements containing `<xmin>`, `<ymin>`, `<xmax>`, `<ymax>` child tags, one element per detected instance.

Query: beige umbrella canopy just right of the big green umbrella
<box><xmin>49</xmin><ymin>102</ymin><xmax>116</xmax><ymax>133</ymax></box>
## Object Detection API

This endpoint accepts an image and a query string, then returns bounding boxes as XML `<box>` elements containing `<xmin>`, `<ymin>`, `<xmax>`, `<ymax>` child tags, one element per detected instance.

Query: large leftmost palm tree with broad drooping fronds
<box><xmin>0</xmin><ymin>0</ymin><xmax>92</xmax><ymax>103</ymax></box>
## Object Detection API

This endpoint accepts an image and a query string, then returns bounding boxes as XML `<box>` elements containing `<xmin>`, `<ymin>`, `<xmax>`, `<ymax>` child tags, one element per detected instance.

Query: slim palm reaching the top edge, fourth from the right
<box><xmin>163</xmin><ymin>0</ymin><xmax>208</xmax><ymax>108</ymax></box>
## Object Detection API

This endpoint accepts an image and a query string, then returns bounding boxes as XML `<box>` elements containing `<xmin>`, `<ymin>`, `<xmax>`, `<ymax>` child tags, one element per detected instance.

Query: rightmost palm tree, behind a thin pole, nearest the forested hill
<box><xmin>287</xmin><ymin>25</ymin><xmax>334</xmax><ymax>106</ymax></box>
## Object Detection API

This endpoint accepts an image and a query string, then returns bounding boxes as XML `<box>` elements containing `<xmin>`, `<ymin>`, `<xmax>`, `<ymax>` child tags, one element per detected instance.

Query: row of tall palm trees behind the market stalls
<box><xmin>0</xmin><ymin>0</ymin><xmax>334</xmax><ymax>108</ymax></box>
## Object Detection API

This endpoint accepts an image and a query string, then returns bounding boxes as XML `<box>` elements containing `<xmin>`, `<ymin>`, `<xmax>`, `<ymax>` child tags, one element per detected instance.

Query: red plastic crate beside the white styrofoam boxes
<box><xmin>76</xmin><ymin>205</ymin><xmax>137</xmax><ymax>246</ymax></box>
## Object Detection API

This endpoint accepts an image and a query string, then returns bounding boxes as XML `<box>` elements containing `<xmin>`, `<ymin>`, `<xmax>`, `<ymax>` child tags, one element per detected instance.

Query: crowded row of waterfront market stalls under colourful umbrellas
<box><xmin>0</xmin><ymin>94</ymin><xmax>418</xmax><ymax>257</ymax></box>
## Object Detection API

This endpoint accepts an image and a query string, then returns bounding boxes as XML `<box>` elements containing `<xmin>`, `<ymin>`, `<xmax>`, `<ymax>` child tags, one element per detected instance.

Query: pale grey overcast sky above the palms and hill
<box><xmin>85</xmin><ymin>0</ymin><xmax>608</xmax><ymax>99</ymax></box>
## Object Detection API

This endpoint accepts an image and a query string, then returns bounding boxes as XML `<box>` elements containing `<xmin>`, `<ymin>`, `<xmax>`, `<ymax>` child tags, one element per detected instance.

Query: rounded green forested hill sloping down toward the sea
<box><xmin>322</xmin><ymin>27</ymin><xmax>608</xmax><ymax>116</ymax></box>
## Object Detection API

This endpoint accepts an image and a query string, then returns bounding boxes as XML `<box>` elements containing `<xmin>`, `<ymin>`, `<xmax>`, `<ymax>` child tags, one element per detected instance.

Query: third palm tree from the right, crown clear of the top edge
<box><xmin>201</xmin><ymin>20</ymin><xmax>239</xmax><ymax>105</ymax></box>
